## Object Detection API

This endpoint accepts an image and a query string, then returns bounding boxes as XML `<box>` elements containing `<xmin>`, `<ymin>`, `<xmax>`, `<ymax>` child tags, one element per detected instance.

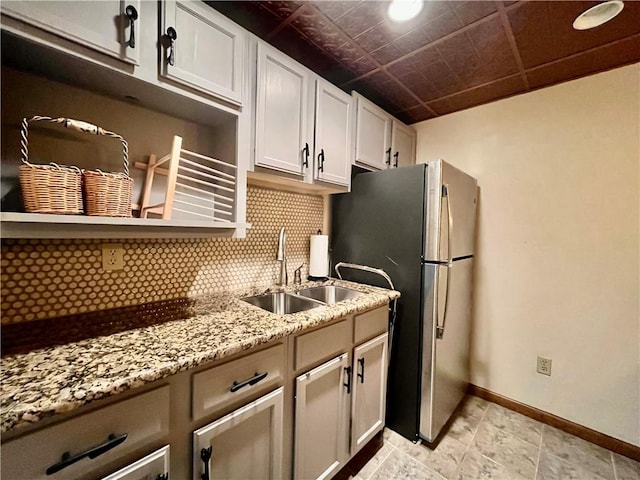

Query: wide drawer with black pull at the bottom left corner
<box><xmin>2</xmin><ymin>386</ymin><xmax>169</xmax><ymax>480</ymax></box>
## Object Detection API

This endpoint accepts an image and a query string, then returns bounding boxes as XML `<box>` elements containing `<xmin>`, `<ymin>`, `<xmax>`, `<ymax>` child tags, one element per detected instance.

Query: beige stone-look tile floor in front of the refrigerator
<box><xmin>352</xmin><ymin>396</ymin><xmax>640</xmax><ymax>480</ymax></box>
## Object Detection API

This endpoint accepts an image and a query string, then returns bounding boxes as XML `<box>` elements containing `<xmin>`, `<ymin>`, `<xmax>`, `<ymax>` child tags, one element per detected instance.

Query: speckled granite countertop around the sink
<box><xmin>0</xmin><ymin>279</ymin><xmax>400</xmax><ymax>433</ymax></box>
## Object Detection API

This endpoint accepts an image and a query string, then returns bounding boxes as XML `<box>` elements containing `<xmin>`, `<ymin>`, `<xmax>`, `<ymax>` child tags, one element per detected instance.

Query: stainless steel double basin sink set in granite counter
<box><xmin>242</xmin><ymin>285</ymin><xmax>362</xmax><ymax>315</ymax></box>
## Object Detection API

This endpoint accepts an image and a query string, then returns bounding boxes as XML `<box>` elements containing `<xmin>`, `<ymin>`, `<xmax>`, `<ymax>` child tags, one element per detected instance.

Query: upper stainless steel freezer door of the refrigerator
<box><xmin>424</xmin><ymin>160</ymin><xmax>478</xmax><ymax>262</ymax></box>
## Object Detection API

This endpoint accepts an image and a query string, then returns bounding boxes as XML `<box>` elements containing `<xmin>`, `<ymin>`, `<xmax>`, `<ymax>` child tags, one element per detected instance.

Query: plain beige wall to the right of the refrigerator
<box><xmin>415</xmin><ymin>64</ymin><xmax>640</xmax><ymax>445</ymax></box>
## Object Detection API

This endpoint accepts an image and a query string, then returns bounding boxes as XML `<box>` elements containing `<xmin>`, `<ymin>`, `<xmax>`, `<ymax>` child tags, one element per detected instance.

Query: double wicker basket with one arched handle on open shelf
<box><xmin>20</xmin><ymin>116</ymin><xmax>133</xmax><ymax>217</ymax></box>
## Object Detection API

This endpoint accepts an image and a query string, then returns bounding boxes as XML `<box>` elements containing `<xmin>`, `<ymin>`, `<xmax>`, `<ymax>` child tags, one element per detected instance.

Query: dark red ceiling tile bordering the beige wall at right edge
<box><xmin>526</xmin><ymin>35</ymin><xmax>640</xmax><ymax>88</ymax></box>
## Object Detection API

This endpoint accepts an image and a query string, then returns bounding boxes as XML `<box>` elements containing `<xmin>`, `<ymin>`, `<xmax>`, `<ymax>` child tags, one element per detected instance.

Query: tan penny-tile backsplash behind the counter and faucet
<box><xmin>1</xmin><ymin>187</ymin><xmax>324</xmax><ymax>324</ymax></box>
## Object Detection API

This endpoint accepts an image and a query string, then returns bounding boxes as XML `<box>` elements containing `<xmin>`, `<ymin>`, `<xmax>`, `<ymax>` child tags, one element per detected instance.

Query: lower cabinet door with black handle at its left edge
<box><xmin>193</xmin><ymin>387</ymin><xmax>284</xmax><ymax>480</ymax></box>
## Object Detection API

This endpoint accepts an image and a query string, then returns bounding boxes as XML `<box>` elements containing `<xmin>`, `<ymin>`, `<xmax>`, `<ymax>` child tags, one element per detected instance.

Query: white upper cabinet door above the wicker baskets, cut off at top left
<box><xmin>2</xmin><ymin>0</ymin><xmax>144</xmax><ymax>65</ymax></box>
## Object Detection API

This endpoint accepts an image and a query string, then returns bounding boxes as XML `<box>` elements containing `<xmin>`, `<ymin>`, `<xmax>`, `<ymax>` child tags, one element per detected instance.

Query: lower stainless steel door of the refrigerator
<box><xmin>420</xmin><ymin>257</ymin><xmax>473</xmax><ymax>442</ymax></box>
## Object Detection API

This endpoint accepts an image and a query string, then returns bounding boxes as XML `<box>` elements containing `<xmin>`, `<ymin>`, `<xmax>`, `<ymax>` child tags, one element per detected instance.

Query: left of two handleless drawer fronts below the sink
<box><xmin>295</xmin><ymin>320</ymin><xmax>351</xmax><ymax>370</ymax></box>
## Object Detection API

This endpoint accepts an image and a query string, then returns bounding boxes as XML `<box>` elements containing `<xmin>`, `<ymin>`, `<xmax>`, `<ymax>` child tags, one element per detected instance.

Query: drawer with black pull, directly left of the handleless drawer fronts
<box><xmin>191</xmin><ymin>344</ymin><xmax>286</xmax><ymax>420</ymax></box>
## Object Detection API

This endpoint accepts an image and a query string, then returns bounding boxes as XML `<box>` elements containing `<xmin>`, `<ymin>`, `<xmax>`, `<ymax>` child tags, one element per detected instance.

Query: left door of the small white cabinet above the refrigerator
<box><xmin>355</xmin><ymin>95</ymin><xmax>391</xmax><ymax>169</ymax></box>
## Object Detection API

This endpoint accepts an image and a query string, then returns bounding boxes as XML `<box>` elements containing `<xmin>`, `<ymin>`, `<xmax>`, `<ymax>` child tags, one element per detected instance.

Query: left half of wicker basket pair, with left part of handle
<box><xmin>18</xmin><ymin>116</ymin><xmax>83</xmax><ymax>215</ymax></box>
